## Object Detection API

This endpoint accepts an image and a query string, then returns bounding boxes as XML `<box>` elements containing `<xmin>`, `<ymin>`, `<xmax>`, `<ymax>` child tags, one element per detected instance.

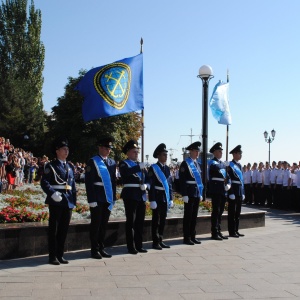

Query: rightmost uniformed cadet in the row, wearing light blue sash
<box><xmin>228</xmin><ymin>145</ymin><xmax>245</xmax><ymax>238</ymax></box>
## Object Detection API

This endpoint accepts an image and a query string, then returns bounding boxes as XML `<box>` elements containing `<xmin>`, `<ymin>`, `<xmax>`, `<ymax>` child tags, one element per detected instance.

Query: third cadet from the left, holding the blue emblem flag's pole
<box><xmin>119</xmin><ymin>140</ymin><xmax>150</xmax><ymax>254</ymax></box>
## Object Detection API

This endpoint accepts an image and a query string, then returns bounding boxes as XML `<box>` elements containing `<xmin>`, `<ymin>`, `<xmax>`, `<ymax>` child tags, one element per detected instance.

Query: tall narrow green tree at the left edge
<box><xmin>0</xmin><ymin>0</ymin><xmax>45</xmax><ymax>152</ymax></box>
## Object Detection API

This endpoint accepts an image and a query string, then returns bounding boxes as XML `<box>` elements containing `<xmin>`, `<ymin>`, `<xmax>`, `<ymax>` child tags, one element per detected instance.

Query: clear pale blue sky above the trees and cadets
<box><xmin>34</xmin><ymin>0</ymin><xmax>300</xmax><ymax>164</ymax></box>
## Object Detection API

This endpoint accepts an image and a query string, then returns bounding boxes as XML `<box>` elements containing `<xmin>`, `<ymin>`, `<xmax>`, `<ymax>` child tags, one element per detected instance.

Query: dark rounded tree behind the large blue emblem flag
<box><xmin>45</xmin><ymin>71</ymin><xmax>142</xmax><ymax>162</ymax></box>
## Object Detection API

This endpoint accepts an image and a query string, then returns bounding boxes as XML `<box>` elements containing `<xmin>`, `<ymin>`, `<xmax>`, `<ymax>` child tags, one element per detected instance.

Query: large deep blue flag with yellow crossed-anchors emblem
<box><xmin>75</xmin><ymin>54</ymin><xmax>144</xmax><ymax>122</ymax></box>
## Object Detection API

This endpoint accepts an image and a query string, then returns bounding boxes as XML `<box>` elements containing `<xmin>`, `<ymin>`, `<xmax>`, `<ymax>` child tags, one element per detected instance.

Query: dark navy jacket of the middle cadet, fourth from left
<box><xmin>148</xmin><ymin>162</ymin><xmax>173</xmax><ymax>202</ymax></box>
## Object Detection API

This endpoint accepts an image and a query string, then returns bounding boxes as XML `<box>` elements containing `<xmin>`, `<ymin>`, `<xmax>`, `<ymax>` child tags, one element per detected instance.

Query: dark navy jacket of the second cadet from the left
<box><xmin>85</xmin><ymin>155</ymin><xmax>117</xmax><ymax>203</ymax></box>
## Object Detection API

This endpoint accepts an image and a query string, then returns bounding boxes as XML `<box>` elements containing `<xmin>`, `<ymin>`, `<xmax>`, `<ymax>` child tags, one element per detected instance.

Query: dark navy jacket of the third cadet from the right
<box><xmin>179</xmin><ymin>161</ymin><xmax>201</xmax><ymax>198</ymax></box>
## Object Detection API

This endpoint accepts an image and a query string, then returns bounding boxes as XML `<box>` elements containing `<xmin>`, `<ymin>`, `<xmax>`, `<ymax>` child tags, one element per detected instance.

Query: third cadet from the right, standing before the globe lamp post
<box><xmin>179</xmin><ymin>142</ymin><xmax>203</xmax><ymax>245</ymax></box>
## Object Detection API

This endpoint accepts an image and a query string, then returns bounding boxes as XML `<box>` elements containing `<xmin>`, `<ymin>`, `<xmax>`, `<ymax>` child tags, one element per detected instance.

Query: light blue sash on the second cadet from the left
<box><xmin>92</xmin><ymin>155</ymin><xmax>114</xmax><ymax>211</ymax></box>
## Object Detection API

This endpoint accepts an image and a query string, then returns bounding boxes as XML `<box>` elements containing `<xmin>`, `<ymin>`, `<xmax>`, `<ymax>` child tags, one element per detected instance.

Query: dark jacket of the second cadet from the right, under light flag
<box><xmin>208</xmin><ymin>157</ymin><xmax>226</xmax><ymax>196</ymax></box>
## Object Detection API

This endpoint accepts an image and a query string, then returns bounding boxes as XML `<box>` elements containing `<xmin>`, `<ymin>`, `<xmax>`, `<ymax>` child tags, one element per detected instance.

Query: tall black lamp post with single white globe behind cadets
<box><xmin>197</xmin><ymin>65</ymin><xmax>214</xmax><ymax>201</ymax></box>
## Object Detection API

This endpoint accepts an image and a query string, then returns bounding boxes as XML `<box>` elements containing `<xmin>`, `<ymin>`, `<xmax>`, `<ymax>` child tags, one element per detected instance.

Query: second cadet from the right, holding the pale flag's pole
<box><xmin>208</xmin><ymin>143</ymin><xmax>230</xmax><ymax>241</ymax></box>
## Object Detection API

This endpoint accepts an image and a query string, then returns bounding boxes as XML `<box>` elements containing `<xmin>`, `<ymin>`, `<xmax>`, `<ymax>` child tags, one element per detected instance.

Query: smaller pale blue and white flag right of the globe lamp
<box><xmin>209</xmin><ymin>81</ymin><xmax>231</xmax><ymax>125</ymax></box>
